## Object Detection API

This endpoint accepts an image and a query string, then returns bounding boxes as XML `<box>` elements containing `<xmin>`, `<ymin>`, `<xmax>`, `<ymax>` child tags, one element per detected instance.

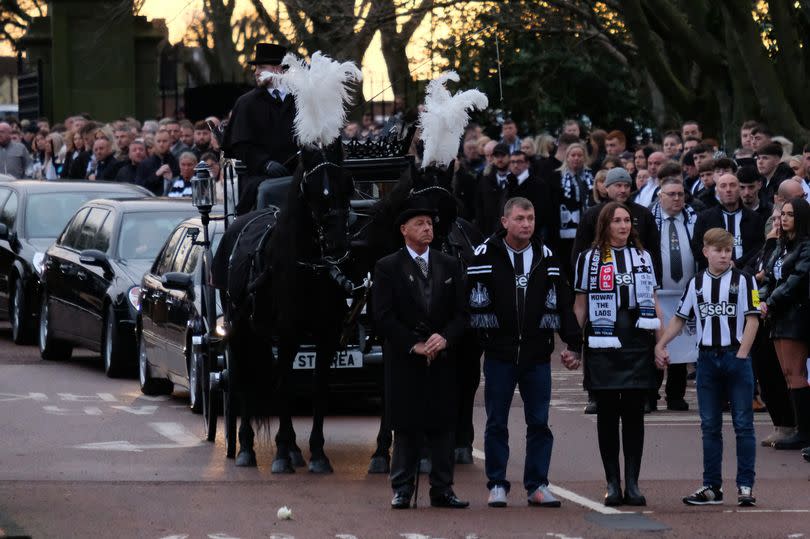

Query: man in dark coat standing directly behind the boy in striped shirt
<box><xmin>692</xmin><ymin>174</ymin><xmax>765</xmax><ymax>270</ymax></box>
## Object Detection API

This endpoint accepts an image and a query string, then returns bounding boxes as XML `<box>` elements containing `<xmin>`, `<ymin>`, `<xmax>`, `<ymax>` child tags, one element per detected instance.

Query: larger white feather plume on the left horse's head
<box><xmin>267</xmin><ymin>51</ymin><xmax>363</xmax><ymax>146</ymax></box>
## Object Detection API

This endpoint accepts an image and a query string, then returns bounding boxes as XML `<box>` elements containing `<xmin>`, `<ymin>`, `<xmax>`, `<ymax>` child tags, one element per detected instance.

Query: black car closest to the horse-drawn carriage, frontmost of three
<box><xmin>137</xmin><ymin>217</ymin><xmax>225</xmax><ymax>413</ymax></box>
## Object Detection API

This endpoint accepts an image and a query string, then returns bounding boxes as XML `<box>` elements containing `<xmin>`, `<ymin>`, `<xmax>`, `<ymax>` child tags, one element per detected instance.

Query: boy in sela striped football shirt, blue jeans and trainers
<box><xmin>655</xmin><ymin>228</ymin><xmax>759</xmax><ymax>506</ymax></box>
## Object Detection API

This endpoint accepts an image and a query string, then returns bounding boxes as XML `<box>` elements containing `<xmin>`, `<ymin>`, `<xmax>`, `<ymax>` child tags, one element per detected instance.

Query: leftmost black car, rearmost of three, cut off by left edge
<box><xmin>0</xmin><ymin>180</ymin><xmax>152</xmax><ymax>344</ymax></box>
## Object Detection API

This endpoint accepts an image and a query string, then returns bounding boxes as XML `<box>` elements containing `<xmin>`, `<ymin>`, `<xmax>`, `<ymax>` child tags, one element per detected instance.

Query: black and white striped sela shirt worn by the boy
<box><xmin>675</xmin><ymin>268</ymin><xmax>759</xmax><ymax>347</ymax></box>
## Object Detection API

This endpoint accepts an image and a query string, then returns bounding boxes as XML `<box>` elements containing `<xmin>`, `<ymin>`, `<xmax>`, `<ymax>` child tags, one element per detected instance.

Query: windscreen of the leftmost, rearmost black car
<box><xmin>25</xmin><ymin>192</ymin><xmax>132</xmax><ymax>238</ymax></box>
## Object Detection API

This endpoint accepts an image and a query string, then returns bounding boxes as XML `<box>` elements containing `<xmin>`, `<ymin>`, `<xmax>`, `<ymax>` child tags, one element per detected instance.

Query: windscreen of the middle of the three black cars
<box><xmin>118</xmin><ymin>211</ymin><xmax>193</xmax><ymax>260</ymax></box>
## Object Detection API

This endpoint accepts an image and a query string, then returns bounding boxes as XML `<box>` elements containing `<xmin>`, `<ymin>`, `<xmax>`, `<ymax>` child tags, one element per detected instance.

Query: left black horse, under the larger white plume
<box><xmin>216</xmin><ymin>142</ymin><xmax>354</xmax><ymax>473</ymax></box>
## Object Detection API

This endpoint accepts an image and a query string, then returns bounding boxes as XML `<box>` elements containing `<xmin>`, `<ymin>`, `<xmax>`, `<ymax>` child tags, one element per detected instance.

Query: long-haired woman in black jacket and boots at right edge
<box><xmin>761</xmin><ymin>198</ymin><xmax>810</xmax><ymax>449</ymax></box>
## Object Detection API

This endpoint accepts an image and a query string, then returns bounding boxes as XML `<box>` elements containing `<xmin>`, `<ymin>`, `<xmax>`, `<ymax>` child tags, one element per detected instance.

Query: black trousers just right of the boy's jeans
<box><xmin>751</xmin><ymin>324</ymin><xmax>796</xmax><ymax>427</ymax></box>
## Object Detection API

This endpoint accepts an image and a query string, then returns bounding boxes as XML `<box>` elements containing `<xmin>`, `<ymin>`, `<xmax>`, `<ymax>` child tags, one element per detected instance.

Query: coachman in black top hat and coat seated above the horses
<box><xmin>223</xmin><ymin>43</ymin><xmax>298</xmax><ymax>215</ymax></box>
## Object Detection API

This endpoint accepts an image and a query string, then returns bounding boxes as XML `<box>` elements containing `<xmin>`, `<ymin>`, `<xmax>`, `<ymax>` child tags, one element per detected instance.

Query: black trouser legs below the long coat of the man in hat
<box><xmin>391</xmin><ymin>429</ymin><xmax>455</xmax><ymax>496</ymax></box>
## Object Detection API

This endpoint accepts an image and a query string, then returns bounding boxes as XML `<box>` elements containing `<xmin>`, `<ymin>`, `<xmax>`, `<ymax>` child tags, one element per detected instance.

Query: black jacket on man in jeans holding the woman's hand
<box><xmin>467</xmin><ymin>231</ymin><xmax>582</xmax><ymax>366</ymax></box>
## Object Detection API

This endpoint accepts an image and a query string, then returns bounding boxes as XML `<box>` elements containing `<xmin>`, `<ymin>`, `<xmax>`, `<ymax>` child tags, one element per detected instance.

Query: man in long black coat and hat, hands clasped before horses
<box><xmin>371</xmin><ymin>199</ymin><xmax>469</xmax><ymax>509</ymax></box>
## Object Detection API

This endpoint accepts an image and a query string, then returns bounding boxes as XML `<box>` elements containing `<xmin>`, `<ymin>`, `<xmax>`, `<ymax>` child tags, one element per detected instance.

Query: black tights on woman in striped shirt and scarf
<box><xmin>593</xmin><ymin>389</ymin><xmax>648</xmax><ymax>481</ymax></box>
